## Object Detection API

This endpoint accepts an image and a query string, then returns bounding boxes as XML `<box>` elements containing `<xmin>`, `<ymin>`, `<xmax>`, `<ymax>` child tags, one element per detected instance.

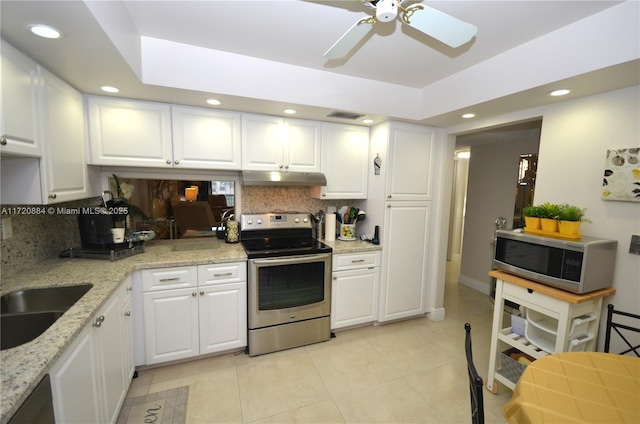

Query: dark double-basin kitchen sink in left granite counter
<box><xmin>0</xmin><ymin>284</ymin><xmax>93</xmax><ymax>350</ymax></box>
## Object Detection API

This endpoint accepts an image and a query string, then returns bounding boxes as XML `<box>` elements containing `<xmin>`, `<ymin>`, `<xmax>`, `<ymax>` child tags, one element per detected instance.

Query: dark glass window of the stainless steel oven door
<box><xmin>258</xmin><ymin>261</ymin><xmax>325</xmax><ymax>311</ymax></box>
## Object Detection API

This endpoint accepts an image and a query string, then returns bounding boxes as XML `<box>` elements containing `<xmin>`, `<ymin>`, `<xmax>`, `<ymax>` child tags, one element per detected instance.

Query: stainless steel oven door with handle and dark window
<box><xmin>247</xmin><ymin>253</ymin><xmax>331</xmax><ymax>329</ymax></box>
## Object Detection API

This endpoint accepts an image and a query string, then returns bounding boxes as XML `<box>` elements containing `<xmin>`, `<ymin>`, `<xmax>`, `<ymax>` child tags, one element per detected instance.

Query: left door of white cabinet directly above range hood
<box><xmin>242</xmin><ymin>114</ymin><xmax>284</xmax><ymax>171</ymax></box>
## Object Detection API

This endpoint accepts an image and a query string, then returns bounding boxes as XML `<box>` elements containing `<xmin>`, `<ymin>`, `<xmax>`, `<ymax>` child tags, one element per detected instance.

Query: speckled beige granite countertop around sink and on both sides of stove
<box><xmin>0</xmin><ymin>238</ymin><xmax>381</xmax><ymax>422</ymax></box>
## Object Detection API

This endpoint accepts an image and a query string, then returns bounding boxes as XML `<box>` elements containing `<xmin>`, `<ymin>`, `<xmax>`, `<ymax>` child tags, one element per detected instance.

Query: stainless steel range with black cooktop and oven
<box><xmin>240</xmin><ymin>212</ymin><xmax>331</xmax><ymax>356</ymax></box>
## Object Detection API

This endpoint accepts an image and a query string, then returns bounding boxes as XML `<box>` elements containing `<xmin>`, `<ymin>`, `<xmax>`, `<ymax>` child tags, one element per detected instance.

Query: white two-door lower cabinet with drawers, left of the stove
<box><xmin>142</xmin><ymin>262</ymin><xmax>247</xmax><ymax>365</ymax></box>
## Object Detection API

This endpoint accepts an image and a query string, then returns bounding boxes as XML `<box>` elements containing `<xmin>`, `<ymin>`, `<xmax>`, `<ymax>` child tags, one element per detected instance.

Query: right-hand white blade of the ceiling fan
<box><xmin>402</xmin><ymin>4</ymin><xmax>478</xmax><ymax>48</ymax></box>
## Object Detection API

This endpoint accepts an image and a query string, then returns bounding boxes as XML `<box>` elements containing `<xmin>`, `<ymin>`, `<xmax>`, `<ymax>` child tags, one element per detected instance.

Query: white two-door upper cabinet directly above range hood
<box><xmin>242</xmin><ymin>114</ymin><xmax>321</xmax><ymax>172</ymax></box>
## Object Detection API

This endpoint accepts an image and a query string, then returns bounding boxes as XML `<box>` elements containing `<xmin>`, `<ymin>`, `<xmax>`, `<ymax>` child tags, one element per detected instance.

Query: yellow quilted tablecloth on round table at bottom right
<box><xmin>502</xmin><ymin>352</ymin><xmax>640</xmax><ymax>424</ymax></box>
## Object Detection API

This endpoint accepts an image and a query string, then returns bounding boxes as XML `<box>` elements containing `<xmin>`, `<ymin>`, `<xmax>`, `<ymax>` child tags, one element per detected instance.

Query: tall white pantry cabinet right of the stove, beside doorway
<box><xmin>366</xmin><ymin>122</ymin><xmax>436</xmax><ymax>322</ymax></box>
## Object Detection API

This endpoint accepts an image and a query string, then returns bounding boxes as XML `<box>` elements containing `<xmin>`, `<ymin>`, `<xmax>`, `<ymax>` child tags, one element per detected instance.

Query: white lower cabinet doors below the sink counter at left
<box><xmin>50</xmin><ymin>282</ymin><xmax>133</xmax><ymax>423</ymax></box>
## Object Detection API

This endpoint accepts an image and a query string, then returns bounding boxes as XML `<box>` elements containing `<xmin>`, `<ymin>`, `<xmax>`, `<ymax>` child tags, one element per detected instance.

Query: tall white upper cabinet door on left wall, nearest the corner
<box><xmin>40</xmin><ymin>69</ymin><xmax>91</xmax><ymax>203</ymax></box>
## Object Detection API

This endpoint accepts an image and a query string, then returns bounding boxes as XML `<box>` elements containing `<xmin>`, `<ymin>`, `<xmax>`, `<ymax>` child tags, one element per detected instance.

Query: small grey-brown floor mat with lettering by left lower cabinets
<box><xmin>116</xmin><ymin>386</ymin><xmax>189</xmax><ymax>424</ymax></box>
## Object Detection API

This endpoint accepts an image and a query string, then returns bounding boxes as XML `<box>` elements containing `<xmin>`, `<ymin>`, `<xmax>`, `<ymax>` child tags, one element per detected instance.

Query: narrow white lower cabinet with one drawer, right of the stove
<box><xmin>331</xmin><ymin>251</ymin><xmax>380</xmax><ymax>330</ymax></box>
